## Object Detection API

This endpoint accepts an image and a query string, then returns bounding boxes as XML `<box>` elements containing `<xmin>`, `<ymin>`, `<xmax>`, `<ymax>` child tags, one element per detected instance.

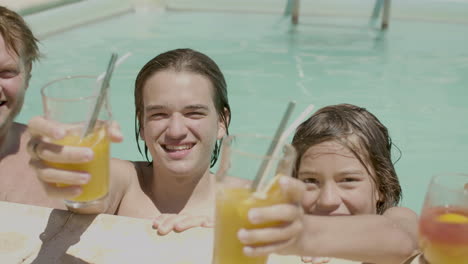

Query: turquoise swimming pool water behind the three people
<box><xmin>18</xmin><ymin>0</ymin><xmax>468</xmax><ymax>212</ymax></box>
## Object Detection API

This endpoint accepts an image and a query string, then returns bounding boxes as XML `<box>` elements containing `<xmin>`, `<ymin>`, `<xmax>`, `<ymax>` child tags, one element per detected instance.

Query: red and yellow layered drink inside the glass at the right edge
<box><xmin>419</xmin><ymin>206</ymin><xmax>468</xmax><ymax>264</ymax></box>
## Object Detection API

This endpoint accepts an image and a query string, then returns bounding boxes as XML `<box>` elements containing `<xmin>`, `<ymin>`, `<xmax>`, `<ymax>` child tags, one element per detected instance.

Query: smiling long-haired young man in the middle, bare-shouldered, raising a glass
<box><xmin>29</xmin><ymin>49</ymin><xmax>243</xmax><ymax>234</ymax></box>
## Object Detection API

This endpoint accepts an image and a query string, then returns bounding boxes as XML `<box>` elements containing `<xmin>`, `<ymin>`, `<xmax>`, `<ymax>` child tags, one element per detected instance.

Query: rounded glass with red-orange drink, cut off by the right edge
<box><xmin>419</xmin><ymin>174</ymin><xmax>468</xmax><ymax>264</ymax></box>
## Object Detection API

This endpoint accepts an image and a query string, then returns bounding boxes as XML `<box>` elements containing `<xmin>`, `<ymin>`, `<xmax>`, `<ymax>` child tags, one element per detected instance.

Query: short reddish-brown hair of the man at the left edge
<box><xmin>0</xmin><ymin>6</ymin><xmax>40</xmax><ymax>74</ymax></box>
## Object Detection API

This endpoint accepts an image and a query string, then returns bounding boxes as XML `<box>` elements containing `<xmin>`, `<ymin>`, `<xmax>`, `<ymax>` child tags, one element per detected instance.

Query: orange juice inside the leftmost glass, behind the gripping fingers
<box><xmin>48</xmin><ymin>124</ymin><xmax>110</xmax><ymax>202</ymax></box>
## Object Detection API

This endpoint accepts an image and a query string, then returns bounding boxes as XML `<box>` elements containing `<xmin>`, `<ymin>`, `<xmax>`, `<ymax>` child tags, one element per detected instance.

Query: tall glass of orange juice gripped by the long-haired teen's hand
<box><xmin>41</xmin><ymin>76</ymin><xmax>111</xmax><ymax>208</ymax></box>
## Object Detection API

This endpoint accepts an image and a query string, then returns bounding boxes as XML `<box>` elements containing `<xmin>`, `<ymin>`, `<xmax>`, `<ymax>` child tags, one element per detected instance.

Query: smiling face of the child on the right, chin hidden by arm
<box><xmin>297</xmin><ymin>141</ymin><xmax>379</xmax><ymax>215</ymax></box>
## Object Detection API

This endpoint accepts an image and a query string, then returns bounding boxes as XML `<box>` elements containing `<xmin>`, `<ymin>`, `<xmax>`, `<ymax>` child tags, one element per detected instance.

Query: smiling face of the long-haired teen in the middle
<box><xmin>141</xmin><ymin>70</ymin><xmax>226</xmax><ymax>177</ymax></box>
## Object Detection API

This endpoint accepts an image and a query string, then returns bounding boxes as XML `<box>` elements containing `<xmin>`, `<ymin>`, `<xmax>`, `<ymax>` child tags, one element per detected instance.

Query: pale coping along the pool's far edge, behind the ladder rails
<box><xmin>0</xmin><ymin>0</ymin><xmax>468</xmax><ymax>39</ymax></box>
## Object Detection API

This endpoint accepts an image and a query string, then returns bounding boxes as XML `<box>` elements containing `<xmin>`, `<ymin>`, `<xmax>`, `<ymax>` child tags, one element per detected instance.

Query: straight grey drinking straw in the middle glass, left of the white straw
<box><xmin>250</xmin><ymin>101</ymin><xmax>296</xmax><ymax>191</ymax></box>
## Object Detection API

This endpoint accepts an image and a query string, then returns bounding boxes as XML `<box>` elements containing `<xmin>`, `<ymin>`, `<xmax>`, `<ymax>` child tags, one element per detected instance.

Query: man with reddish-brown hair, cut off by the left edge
<box><xmin>0</xmin><ymin>6</ymin><xmax>64</xmax><ymax>208</ymax></box>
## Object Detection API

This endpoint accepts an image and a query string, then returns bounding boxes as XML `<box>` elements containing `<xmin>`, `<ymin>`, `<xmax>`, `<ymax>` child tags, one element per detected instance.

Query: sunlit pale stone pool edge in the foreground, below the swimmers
<box><xmin>0</xmin><ymin>202</ymin><xmax>372</xmax><ymax>264</ymax></box>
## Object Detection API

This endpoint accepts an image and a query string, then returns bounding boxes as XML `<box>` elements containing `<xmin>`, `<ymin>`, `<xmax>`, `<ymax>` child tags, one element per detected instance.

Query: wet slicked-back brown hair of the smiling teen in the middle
<box><xmin>135</xmin><ymin>49</ymin><xmax>231</xmax><ymax>167</ymax></box>
